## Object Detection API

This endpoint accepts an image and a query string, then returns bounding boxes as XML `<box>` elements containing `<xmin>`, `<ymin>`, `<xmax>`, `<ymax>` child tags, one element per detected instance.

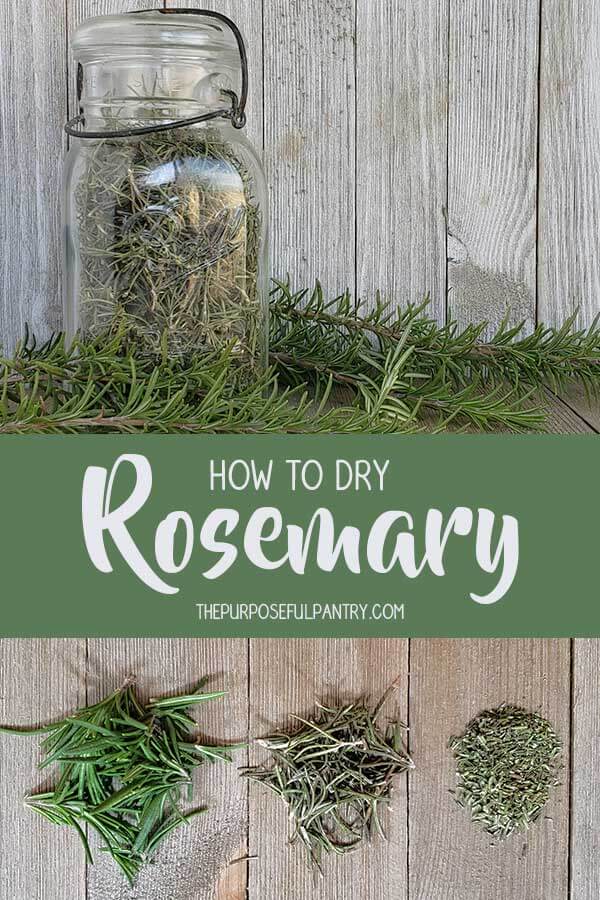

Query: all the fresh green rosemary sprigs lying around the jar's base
<box><xmin>0</xmin><ymin>284</ymin><xmax>600</xmax><ymax>434</ymax></box>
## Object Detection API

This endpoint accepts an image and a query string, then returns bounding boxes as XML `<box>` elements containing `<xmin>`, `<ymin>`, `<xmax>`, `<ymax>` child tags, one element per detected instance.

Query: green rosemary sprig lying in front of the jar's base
<box><xmin>0</xmin><ymin>328</ymin><xmax>417</xmax><ymax>434</ymax></box>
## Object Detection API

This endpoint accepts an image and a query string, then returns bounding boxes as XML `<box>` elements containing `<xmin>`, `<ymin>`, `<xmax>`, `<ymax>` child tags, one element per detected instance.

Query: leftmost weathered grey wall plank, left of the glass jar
<box><xmin>0</xmin><ymin>0</ymin><xmax>66</xmax><ymax>351</ymax></box>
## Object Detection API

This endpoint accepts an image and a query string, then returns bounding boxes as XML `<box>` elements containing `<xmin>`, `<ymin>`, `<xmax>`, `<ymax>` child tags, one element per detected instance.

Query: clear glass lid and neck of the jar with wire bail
<box><xmin>65</xmin><ymin>9</ymin><xmax>248</xmax><ymax>138</ymax></box>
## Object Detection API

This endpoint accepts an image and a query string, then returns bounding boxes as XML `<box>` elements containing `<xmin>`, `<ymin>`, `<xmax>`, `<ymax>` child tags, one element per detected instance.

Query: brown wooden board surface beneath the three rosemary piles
<box><xmin>0</xmin><ymin>639</ymin><xmax>600</xmax><ymax>900</ymax></box>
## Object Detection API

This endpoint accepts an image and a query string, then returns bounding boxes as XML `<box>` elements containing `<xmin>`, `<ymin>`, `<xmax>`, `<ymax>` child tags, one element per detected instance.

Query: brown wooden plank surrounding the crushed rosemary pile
<box><xmin>409</xmin><ymin>639</ymin><xmax>570</xmax><ymax>900</ymax></box>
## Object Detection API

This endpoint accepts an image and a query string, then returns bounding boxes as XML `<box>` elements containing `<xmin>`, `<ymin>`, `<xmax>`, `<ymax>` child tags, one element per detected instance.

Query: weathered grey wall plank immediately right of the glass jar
<box><xmin>264</xmin><ymin>0</ymin><xmax>355</xmax><ymax>292</ymax></box>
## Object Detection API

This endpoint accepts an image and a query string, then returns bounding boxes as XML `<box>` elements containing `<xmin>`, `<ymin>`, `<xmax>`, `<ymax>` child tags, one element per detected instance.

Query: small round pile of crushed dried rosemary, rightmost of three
<box><xmin>450</xmin><ymin>705</ymin><xmax>561</xmax><ymax>838</ymax></box>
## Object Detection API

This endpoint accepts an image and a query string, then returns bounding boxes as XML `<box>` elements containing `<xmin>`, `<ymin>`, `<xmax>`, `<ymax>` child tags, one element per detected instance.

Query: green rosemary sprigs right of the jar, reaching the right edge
<box><xmin>270</xmin><ymin>282</ymin><xmax>600</xmax><ymax>432</ymax></box>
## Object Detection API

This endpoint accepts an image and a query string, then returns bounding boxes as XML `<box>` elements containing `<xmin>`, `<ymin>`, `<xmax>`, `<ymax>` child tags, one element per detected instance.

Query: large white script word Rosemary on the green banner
<box><xmin>82</xmin><ymin>454</ymin><xmax>519</xmax><ymax>604</ymax></box>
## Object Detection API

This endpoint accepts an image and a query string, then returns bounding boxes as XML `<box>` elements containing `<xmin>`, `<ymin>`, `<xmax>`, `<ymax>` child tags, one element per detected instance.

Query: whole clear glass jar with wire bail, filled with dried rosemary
<box><xmin>65</xmin><ymin>10</ymin><xmax>268</xmax><ymax>378</ymax></box>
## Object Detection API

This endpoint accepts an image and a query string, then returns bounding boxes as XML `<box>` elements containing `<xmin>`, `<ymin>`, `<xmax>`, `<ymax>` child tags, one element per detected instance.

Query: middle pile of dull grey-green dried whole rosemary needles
<box><xmin>242</xmin><ymin>692</ymin><xmax>414</xmax><ymax>871</ymax></box>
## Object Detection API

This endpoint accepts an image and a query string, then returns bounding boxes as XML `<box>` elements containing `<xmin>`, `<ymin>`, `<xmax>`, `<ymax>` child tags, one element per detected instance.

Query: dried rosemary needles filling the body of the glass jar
<box><xmin>75</xmin><ymin>128</ymin><xmax>266</xmax><ymax>381</ymax></box>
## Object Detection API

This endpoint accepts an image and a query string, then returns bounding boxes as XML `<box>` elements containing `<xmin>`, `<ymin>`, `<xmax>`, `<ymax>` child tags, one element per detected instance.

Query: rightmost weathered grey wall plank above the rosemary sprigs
<box><xmin>539</xmin><ymin>0</ymin><xmax>600</xmax><ymax>324</ymax></box>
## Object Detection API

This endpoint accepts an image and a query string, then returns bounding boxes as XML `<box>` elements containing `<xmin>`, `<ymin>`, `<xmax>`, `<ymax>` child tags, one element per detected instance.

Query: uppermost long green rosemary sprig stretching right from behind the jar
<box><xmin>271</xmin><ymin>282</ymin><xmax>600</xmax><ymax>397</ymax></box>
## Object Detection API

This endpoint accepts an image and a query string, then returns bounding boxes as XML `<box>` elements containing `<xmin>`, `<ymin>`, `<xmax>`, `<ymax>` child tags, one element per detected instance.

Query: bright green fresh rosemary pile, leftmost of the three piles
<box><xmin>0</xmin><ymin>679</ymin><xmax>240</xmax><ymax>883</ymax></box>
